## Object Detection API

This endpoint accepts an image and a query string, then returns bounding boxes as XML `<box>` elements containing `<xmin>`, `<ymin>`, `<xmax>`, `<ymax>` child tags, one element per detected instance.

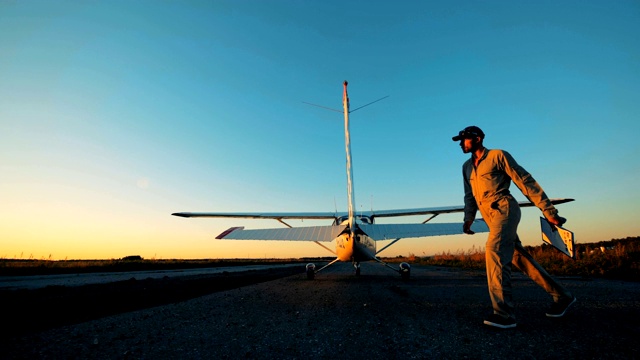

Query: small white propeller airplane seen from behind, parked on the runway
<box><xmin>172</xmin><ymin>81</ymin><xmax>573</xmax><ymax>279</ymax></box>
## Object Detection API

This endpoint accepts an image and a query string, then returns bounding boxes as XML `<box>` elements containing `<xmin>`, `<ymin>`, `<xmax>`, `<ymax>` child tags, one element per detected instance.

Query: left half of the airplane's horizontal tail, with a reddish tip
<box><xmin>216</xmin><ymin>225</ymin><xmax>346</xmax><ymax>241</ymax></box>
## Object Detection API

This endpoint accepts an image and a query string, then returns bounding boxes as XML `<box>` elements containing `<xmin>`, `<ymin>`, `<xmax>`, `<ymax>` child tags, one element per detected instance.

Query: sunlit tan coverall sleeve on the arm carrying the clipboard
<box><xmin>502</xmin><ymin>151</ymin><xmax>558</xmax><ymax>217</ymax></box>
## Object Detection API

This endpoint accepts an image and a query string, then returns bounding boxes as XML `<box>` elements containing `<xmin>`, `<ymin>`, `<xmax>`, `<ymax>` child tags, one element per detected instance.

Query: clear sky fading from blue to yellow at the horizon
<box><xmin>0</xmin><ymin>0</ymin><xmax>640</xmax><ymax>260</ymax></box>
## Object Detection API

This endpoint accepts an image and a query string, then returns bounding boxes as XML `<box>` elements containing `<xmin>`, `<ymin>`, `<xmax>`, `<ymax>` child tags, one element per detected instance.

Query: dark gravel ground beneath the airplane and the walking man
<box><xmin>0</xmin><ymin>263</ymin><xmax>640</xmax><ymax>359</ymax></box>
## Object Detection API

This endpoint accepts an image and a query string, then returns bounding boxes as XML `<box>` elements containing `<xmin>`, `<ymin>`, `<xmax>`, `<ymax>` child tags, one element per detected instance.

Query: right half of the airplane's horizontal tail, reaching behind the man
<box><xmin>358</xmin><ymin>219</ymin><xmax>489</xmax><ymax>241</ymax></box>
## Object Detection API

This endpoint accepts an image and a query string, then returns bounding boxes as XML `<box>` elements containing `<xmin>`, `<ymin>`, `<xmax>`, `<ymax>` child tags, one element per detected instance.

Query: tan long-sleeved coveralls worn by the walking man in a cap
<box><xmin>462</xmin><ymin>149</ymin><xmax>572</xmax><ymax>319</ymax></box>
